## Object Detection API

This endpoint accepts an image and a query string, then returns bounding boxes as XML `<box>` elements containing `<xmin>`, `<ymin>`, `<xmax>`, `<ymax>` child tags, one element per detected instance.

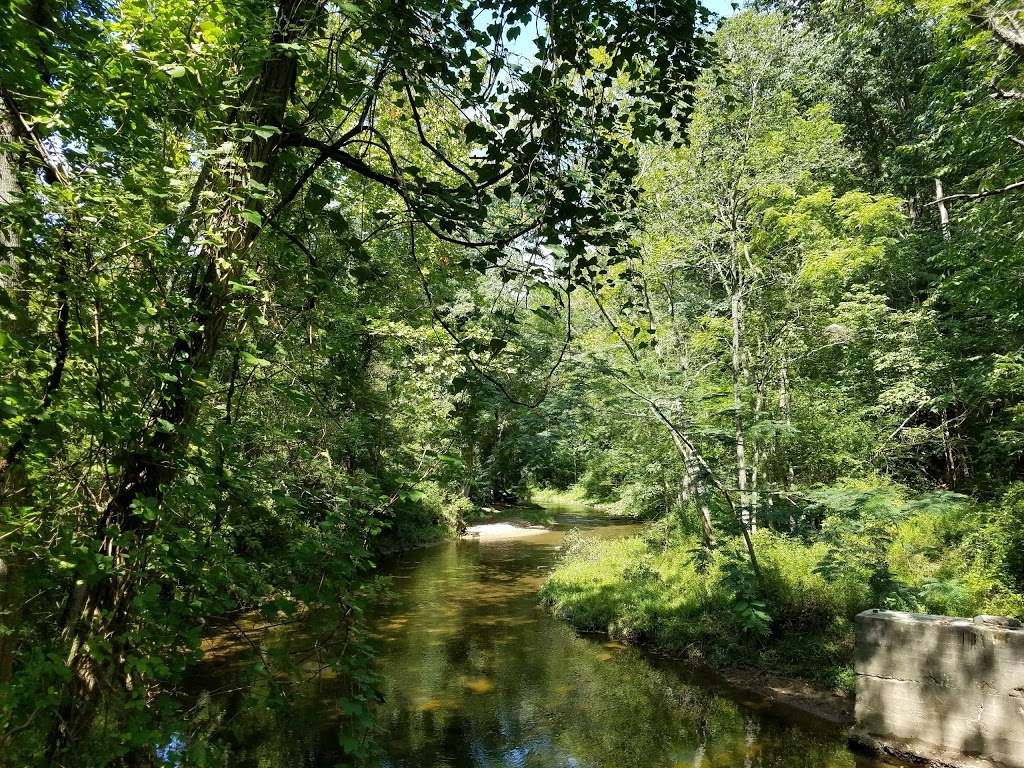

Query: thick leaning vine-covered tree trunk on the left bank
<box><xmin>48</xmin><ymin>0</ymin><xmax>321</xmax><ymax>764</ymax></box>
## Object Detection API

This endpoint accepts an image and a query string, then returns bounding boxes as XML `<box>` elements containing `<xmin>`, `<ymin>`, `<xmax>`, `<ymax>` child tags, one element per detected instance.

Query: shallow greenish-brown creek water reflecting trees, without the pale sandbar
<box><xmin>176</xmin><ymin>508</ymin><xmax>888</xmax><ymax>768</ymax></box>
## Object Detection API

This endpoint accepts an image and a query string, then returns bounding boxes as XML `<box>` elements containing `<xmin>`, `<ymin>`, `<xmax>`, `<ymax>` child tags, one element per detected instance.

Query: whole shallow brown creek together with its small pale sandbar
<box><xmin>189</xmin><ymin>504</ymin><xmax>897</xmax><ymax>768</ymax></box>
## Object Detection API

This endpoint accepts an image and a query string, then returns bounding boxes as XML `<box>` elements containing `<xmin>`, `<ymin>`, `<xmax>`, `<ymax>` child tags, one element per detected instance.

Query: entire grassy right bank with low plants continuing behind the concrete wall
<box><xmin>542</xmin><ymin>488</ymin><xmax>1024</xmax><ymax>691</ymax></box>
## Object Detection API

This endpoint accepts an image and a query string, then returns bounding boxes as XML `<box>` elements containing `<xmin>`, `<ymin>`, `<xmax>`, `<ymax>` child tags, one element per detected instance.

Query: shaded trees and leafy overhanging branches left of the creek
<box><xmin>0</xmin><ymin>0</ymin><xmax>702</xmax><ymax>765</ymax></box>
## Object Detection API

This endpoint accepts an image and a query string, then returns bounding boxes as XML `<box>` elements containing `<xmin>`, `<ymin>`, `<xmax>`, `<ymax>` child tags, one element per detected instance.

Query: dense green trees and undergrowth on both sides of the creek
<box><xmin>0</xmin><ymin>0</ymin><xmax>1024</xmax><ymax>766</ymax></box>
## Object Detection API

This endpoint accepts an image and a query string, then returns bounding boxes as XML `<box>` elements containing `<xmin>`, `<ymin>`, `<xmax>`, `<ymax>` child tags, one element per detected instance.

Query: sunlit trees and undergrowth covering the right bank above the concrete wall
<box><xmin>544</xmin><ymin>1</ymin><xmax>1024</xmax><ymax>687</ymax></box>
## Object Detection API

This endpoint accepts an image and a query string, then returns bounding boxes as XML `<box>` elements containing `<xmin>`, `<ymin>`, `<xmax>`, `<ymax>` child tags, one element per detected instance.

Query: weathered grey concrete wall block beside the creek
<box><xmin>850</xmin><ymin>610</ymin><xmax>1024</xmax><ymax>768</ymax></box>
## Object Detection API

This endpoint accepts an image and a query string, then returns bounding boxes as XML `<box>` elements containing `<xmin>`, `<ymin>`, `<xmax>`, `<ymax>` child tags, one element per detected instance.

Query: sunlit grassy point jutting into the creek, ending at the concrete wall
<box><xmin>541</xmin><ymin>528</ymin><xmax>869</xmax><ymax>696</ymax></box>
